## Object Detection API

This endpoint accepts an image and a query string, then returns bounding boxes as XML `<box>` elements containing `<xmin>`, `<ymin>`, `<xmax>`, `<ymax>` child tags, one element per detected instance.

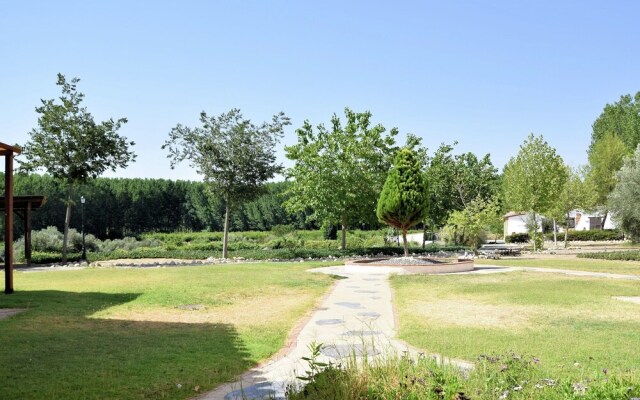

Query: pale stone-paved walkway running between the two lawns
<box><xmin>198</xmin><ymin>266</ymin><xmax>470</xmax><ymax>400</ymax></box>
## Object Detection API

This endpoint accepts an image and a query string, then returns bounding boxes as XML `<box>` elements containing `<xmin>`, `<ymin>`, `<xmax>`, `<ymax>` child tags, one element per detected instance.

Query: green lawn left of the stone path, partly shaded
<box><xmin>0</xmin><ymin>263</ymin><xmax>331</xmax><ymax>399</ymax></box>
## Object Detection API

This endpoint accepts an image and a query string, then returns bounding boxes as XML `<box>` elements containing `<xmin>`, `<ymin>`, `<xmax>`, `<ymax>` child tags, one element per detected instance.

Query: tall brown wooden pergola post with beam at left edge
<box><xmin>0</xmin><ymin>142</ymin><xmax>20</xmax><ymax>294</ymax></box>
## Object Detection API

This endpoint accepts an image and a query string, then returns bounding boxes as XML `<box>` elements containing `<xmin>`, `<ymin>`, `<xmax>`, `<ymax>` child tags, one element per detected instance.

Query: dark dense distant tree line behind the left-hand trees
<box><xmin>0</xmin><ymin>174</ymin><xmax>317</xmax><ymax>239</ymax></box>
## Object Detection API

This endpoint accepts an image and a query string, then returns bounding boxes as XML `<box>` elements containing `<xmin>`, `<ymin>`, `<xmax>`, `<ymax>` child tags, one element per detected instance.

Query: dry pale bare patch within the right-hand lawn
<box><xmin>410</xmin><ymin>299</ymin><xmax>538</xmax><ymax>330</ymax></box>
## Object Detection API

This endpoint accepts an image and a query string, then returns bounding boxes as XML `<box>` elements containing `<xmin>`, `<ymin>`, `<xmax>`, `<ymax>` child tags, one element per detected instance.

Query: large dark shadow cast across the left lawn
<box><xmin>0</xmin><ymin>290</ymin><xmax>256</xmax><ymax>399</ymax></box>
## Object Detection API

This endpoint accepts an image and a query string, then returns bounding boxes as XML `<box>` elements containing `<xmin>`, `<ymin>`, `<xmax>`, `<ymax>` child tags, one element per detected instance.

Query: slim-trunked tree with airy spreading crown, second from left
<box><xmin>162</xmin><ymin>108</ymin><xmax>290</xmax><ymax>258</ymax></box>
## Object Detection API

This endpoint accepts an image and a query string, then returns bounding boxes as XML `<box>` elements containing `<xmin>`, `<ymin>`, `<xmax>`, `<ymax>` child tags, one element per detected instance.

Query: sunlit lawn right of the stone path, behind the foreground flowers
<box><xmin>392</xmin><ymin>272</ymin><xmax>640</xmax><ymax>376</ymax></box>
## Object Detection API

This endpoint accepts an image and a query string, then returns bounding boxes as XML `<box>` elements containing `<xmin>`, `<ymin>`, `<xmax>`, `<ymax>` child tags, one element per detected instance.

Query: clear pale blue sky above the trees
<box><xmin>0</xmin><ymin>0</ymin><xmax>640</xmax><ymax>179</ymax></box>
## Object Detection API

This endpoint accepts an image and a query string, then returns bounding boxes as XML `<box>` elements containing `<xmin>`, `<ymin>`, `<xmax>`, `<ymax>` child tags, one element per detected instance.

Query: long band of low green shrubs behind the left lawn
<box><xmin>14</xmin><ymin>226</ymin><xmax>468</xmax><ymax>264</ymax></box>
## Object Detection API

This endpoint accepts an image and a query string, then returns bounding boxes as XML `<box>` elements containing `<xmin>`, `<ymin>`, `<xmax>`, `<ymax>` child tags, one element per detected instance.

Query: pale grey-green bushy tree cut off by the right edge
<box><xmin>609</xmin><ymin>145</ymin><xmax>640</xmax><ymax>241</ymax></box>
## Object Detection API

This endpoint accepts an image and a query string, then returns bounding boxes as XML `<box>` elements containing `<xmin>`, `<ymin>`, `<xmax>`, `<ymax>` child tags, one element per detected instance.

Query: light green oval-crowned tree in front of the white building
<box><xmin>503</xmin><ymin>133</ymin><xmax>567</xmax><ymax>251</ymax></box>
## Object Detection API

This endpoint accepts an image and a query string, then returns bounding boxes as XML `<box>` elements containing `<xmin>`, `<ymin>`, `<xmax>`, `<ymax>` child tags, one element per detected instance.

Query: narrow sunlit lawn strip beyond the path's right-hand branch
<box><xmin>474</xmin><ymin>257</ymin><xmax>640</xmax><ymax>275</ymax></box>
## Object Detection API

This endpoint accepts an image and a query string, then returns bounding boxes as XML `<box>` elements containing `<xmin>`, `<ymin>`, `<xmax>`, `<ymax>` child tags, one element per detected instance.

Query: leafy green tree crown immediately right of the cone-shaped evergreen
<box><xmin>426</xmin><ymin>143</ymin><xmax>499</xmax><ymax>227</ymax></box>
